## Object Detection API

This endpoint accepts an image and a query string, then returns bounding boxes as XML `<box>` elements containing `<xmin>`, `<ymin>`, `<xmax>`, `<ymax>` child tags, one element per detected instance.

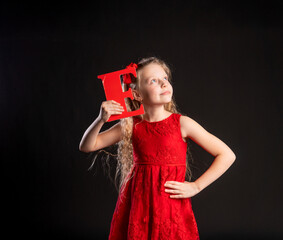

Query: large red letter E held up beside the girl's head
<box><xmin>97</xmin><ymin>66</ymin><xmax>144</xmax><ymax>122</ymax></box>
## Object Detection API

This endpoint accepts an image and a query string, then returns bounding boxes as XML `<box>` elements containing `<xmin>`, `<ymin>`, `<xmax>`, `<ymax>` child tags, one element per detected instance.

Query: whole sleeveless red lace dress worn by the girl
<box><xmin>109</xmin><ymin>113</ymin><xmax>199</xmax><ymax>240</ymax></box>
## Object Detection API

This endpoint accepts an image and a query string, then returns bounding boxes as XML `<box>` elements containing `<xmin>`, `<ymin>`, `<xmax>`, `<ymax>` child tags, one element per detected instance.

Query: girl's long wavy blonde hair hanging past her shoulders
<box><xmin>89</xmin><ymin>57</ymin><xmax>197</xmax><ymax>199</ymax></box>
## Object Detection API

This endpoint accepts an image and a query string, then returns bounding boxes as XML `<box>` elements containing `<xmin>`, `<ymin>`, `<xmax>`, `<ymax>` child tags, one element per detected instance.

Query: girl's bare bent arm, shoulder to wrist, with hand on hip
<box><xmin>180</xmin><ymin>116</ymin><xmax>236</xmax><ymax>192</ymax></box>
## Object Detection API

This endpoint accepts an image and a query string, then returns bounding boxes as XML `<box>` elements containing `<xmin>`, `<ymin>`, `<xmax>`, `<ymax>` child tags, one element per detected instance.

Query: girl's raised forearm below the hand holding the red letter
<box><xmin>79</xmin><ymin>117</ymin><xmax>104</xmax><ymax>152</ymax></box>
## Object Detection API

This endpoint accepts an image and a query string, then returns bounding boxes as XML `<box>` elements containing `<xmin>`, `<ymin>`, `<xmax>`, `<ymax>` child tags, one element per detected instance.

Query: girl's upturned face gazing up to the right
<box><xmin>139</xmin><ymin>63</ymin><xmax>173</xmax><ymax>105</ymax></box>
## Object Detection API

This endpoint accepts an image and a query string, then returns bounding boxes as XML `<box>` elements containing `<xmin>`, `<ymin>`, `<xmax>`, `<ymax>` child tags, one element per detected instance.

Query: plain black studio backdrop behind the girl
<box><xmin>0</xmin><ymin>0</ymin><xmax>283</xmax><ymax>240</ymax></box>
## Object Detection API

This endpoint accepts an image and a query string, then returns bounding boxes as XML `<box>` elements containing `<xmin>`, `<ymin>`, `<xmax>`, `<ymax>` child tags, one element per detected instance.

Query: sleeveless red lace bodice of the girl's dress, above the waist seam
<box><xmin>132</xmin><ymin>114</ymin><xmax>187</xmax><ymax>166</ymax></box>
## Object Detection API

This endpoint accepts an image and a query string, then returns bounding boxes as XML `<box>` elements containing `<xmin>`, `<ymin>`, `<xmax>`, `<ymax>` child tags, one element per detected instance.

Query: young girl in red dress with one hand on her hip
<box><xmin>80</xmin><ymin>57</ymin><xmax>236</xmax><ymax>240</ymax></box>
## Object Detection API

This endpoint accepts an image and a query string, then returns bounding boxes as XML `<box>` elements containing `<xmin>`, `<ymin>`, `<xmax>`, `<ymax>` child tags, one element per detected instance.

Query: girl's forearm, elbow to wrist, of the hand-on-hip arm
<box><xmin>194</xmin><ymin>154</ymin><xmax>236</xmax><ymax>192</ymax></box>
